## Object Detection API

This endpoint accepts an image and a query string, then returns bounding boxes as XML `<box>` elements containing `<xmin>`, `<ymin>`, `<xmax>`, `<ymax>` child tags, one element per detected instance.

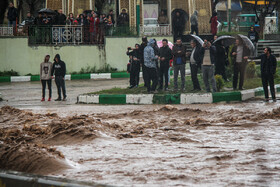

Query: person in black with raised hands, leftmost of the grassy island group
<box><xmin>126</xmin><ymin>44</ymin><xmax>141</xmax><ymax>88</ymax></box>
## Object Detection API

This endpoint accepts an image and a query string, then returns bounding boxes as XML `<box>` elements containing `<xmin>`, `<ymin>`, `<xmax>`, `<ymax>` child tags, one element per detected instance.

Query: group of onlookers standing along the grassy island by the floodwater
<box><xmin>127</xmin><ymin>36</ymin><xmax>277</xmax><ymax>100</ymax></box>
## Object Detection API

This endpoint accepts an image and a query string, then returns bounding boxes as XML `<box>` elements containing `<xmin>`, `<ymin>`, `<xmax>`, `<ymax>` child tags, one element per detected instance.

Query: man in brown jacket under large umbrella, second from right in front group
<box><xmin>231</xmin><ymin>38</ymin><xmax>250</xmax><ymax>90</ymax></box>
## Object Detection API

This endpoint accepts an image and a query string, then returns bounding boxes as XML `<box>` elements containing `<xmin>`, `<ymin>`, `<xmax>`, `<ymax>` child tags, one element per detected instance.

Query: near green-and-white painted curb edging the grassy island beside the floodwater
<box><xmin>77</xmin><ymin>85</ymin><xmax>280</xmax><ymax>105</ymax></box>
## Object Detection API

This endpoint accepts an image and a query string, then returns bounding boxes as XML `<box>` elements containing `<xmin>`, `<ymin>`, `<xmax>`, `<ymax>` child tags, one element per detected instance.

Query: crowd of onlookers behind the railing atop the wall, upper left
<box><xmin>7</xmin><ymin>2</ymin><xmax>129</xmax><ymax>44</ymax></box>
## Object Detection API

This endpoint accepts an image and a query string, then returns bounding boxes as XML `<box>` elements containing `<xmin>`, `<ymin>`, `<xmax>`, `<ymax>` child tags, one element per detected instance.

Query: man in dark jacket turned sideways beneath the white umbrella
<box><xmin>188</xmin><ymin>40</ymin><xmax>202</xmax><ymax>91</ymax></box>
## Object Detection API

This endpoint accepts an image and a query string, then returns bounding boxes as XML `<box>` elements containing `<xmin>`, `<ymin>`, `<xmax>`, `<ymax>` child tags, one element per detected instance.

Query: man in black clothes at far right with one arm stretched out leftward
<box><xmin>250</xmin><ymin>47</ymin><xmax>277</xmax><ymax>101</ymax></box>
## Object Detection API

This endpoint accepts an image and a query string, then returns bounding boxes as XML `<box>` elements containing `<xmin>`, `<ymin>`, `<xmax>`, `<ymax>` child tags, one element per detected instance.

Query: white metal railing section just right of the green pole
<box><xmin>140</xmin><ymin>24</ymin><xmax>172</xmax><ymax>35</ymax></box>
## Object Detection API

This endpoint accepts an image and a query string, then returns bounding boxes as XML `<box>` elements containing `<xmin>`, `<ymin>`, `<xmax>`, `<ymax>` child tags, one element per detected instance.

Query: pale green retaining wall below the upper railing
<box><xmin>0</xmin><ymin>36</ymin><xmax>172</xmax><ymax>75</ymax></box>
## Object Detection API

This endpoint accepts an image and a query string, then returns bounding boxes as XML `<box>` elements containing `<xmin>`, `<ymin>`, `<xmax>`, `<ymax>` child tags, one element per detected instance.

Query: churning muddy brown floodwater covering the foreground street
<box><xmin>0</xmin><ymin>82</ymin><xmax>280</xmax><ymax>186</ymax></box>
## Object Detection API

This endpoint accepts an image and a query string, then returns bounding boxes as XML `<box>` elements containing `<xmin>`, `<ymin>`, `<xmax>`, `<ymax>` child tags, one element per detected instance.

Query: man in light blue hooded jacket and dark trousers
<box><xmin>144</xmin><ymin>39</ymin><xmax>158</xmax><ymax>93</ymax></box>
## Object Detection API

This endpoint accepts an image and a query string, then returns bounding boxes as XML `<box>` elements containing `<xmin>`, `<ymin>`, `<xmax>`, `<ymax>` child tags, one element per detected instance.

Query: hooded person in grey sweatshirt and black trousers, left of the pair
<box><xmin>40</xmin><ymin>55</ymin><xmax>52</xmax><ymax>101</ymax></box>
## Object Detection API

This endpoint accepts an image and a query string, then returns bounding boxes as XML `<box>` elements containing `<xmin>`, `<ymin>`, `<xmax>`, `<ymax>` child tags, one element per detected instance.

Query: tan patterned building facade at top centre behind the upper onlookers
<box><xmin>117</xmin><ymin>0</ymin><xmax>212</xmax><ymax>33</ymax></box>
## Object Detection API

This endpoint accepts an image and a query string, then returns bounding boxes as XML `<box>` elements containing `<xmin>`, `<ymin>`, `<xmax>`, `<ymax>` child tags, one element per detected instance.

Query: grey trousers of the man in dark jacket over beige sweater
<box><xmin>202</xmin><ymin>65</ymin><xmax>217</xmax><ymax>92</ymax></box>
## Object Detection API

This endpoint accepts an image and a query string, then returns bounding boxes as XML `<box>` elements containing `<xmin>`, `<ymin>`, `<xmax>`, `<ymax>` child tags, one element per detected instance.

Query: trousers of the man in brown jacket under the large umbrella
<box><xmin>232</xmin><ymin>62</ymin><xmax>246</xmax><ymax>90</ymax></box>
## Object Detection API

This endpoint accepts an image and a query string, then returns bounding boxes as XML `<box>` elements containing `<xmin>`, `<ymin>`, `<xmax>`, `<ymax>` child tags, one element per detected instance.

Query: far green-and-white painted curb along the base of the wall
<box><xmin>0</xmin><ymin>72</ymin><xmax>131</xmax><ymax>82</ymax></box>
